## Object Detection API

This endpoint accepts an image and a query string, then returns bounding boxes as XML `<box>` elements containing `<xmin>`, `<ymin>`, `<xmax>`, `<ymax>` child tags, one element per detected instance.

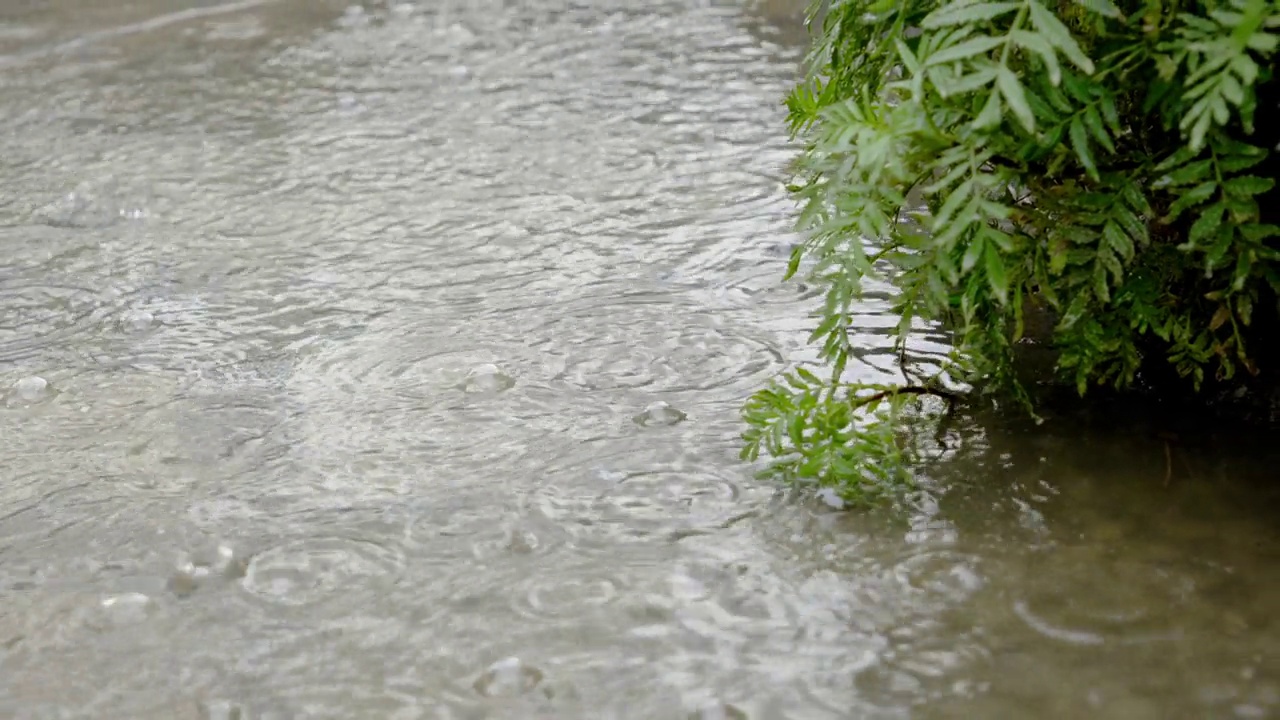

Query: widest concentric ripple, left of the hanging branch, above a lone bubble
<box><xmin>501</xmin><ymin>293</ymin><xmax>786</xmax><ymax>393</ymax></box>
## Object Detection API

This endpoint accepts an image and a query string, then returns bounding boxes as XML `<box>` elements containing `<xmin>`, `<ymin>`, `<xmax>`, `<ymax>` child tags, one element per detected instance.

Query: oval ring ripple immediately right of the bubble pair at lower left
<box><xmin>241</xmin><ymin>537</ymin><xmax>404</xmax><ymax>607</ymax></box>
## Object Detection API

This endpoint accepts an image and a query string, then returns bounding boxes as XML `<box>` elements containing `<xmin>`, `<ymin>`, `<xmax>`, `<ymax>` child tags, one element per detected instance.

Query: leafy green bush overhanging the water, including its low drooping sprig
<box><xmin>744</xmin><ymin>0</ymin><xmax>1280</xmax><ymax>501</ymax></box>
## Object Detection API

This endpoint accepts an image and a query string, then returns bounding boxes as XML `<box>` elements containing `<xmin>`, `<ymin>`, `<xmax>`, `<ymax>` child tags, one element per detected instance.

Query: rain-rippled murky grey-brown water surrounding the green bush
<box><xmin>0</xmin><ymin>0</ymin><xmax>1280</xmax><ymax>720</ymax></box>
